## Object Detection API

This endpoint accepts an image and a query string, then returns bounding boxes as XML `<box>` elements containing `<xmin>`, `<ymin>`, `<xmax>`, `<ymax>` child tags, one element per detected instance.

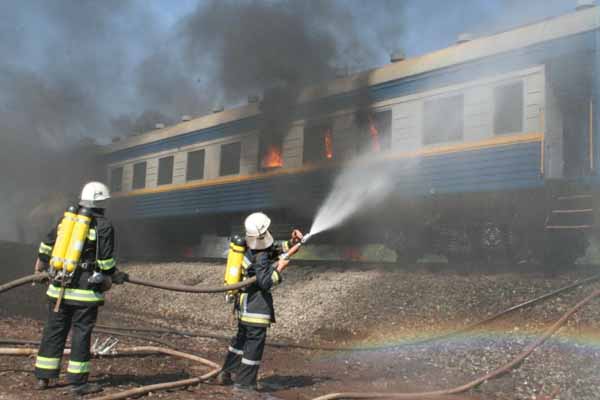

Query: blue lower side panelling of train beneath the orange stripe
<box><xmin>117</xmin><ymin>142</ymin><xmax>543</xmax><ymax>218</ymax></box>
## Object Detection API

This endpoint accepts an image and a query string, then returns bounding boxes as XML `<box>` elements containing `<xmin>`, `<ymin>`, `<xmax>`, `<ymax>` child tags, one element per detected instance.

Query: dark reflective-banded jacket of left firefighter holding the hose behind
<box><xmin>38</xmin><ymin>208</ymin><xmax>116</xmax><ymax>306</ymax></box>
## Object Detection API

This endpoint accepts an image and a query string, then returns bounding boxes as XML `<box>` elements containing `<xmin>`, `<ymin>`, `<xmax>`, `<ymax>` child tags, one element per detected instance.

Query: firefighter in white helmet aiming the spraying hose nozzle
<box><xmin>217</xmin><ymin>212</ymin><xmax>302</xmax><ymax>390</ymax></box>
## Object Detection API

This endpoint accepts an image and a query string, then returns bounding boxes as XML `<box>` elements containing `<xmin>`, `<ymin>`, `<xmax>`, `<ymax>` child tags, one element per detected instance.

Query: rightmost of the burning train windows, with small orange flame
<box><xmin>357</xmin><ymin>110</ymin><xmax>392</xmax><ymax>153</ymax></box>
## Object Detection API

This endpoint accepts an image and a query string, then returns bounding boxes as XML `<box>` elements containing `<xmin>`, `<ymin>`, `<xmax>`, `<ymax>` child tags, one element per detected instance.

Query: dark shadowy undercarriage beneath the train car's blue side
<box><xmin>117</xmin><ymin>182</ymin><xmax>594</xmax><ymax>269</ymax></box>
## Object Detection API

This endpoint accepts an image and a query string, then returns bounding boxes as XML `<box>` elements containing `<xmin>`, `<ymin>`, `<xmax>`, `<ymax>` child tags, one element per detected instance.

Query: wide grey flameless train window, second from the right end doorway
<box><xmin>423</xmin><ymin>94</ymin><xmax>464</xmax><ymax>145</ymax></box>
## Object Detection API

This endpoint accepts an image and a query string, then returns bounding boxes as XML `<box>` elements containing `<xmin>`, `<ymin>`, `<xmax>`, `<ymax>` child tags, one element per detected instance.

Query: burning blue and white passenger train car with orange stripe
<box><xmin>104</xmin><ymin>3</ymin><xmax>600</xmax><ymax>264</ymax></box>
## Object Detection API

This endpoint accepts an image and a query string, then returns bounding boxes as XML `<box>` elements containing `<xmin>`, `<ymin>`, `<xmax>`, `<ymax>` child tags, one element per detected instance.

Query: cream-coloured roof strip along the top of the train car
<box><xmin>105</xmin><ymin>7</ymin><xmax>600</xmax><ymax>153</ymax></box>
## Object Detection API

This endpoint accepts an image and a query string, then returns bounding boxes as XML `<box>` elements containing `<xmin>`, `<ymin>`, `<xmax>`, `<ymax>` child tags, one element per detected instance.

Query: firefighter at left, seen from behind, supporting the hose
<box><xmin>35</xmin><ymin>182</ymin><xmax>126</xmax><ymax>395</ymax></box>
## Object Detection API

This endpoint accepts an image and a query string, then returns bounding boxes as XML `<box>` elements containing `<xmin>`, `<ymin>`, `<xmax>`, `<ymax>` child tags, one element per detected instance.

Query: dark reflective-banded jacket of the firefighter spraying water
<box><xmin>237</xmin><ymin>241</ymin><xmax>290</xmax><ymax>327</ymax></box>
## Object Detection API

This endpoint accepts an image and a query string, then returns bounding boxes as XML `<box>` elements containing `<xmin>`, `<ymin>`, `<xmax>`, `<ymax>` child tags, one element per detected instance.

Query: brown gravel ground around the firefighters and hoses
<box><xmin>0</xmin><ymin>263</ymin><xmax>600</xmax><ymax>400</ymax></box>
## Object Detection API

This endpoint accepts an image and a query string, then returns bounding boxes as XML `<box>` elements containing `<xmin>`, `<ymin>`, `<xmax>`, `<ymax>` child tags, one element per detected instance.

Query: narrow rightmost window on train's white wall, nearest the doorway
<box><xmin>494</xmin><ymin>82</ymin><xmax>523</xmax><ymax>135</ymax></box>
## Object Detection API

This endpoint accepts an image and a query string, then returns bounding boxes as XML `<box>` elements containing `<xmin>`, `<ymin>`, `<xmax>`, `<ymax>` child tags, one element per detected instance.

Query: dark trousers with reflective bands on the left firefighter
<box><xmin>35</xmin><ymin>303</ymin><xmax>98</xmax><ymax>385</ymax></box>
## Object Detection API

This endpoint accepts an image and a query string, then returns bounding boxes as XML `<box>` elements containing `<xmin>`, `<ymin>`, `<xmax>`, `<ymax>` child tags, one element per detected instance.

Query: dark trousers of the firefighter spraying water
<box><xmin>223</xmin><ymin>323</ymin><xmax>267</xmax><ymax>386</ymax></box>
